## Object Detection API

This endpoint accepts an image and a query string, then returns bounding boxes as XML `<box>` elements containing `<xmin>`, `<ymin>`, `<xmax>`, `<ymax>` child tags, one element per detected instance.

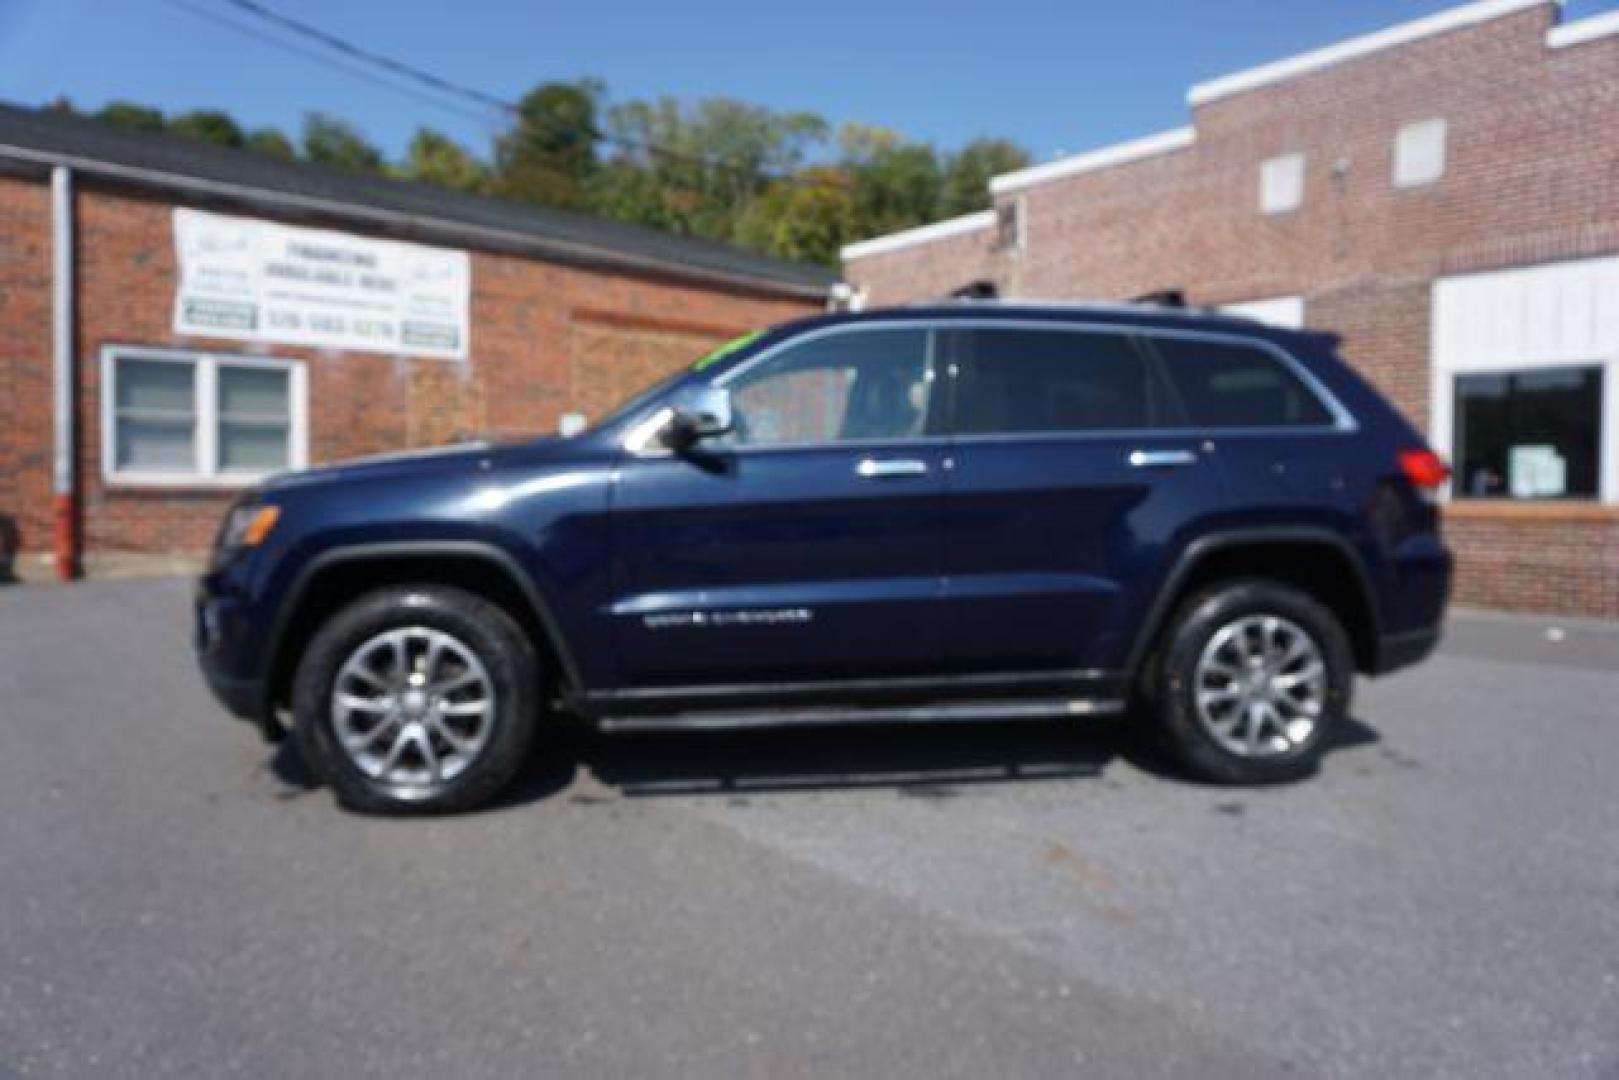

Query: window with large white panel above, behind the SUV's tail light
<box><xmin>1430</xmin><ymin>257</ymin><xmax>1619</xmax><ymax>505</ymax></box>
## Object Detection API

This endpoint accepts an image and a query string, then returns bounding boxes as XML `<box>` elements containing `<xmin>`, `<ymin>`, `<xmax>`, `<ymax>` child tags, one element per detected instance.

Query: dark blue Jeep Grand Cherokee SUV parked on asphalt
<box><xmin>196</xmin><ymin>303</ymin><xmax>1451</xmax><ymax>811</ymax></box>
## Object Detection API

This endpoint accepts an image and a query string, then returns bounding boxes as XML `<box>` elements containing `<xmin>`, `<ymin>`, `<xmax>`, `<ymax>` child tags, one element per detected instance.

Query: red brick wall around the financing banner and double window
<box><xmin>0</xmin><ymin>178</ymin><xmax>813</xmax><ymax>562</ymax></box>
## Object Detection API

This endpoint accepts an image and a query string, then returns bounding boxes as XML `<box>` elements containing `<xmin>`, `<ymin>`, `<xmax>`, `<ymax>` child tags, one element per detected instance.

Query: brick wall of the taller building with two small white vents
<box><xmin>845</xmin><ymin>3</ymin><xmax>1619</xmax><ymax>617</ymax></box>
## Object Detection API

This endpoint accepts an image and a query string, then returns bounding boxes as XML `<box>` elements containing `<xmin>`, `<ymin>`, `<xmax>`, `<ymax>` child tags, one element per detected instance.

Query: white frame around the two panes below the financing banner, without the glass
<box><xmin>100</xmin><ymin>345</ymin><xmax>309</xmax><ymax>491</ymax></box>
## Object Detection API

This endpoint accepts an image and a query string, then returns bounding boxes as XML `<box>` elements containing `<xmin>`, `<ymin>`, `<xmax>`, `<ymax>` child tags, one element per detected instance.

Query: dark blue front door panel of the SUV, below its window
<box><xmin>612</xmin><ymin>445</ymin><xmax>942</xmax><ymax>685</ymax></box>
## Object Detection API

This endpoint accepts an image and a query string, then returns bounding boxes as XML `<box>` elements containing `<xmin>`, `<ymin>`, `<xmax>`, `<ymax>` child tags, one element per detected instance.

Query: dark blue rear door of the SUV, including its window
<box><xmin>942</xmin><ymin>329</ymin><xmax>1222</xmax><ymax>672</ymax></box>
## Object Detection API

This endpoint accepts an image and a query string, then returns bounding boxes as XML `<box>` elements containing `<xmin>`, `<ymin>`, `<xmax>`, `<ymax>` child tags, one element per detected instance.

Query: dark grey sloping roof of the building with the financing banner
<box><xmin>0</xmin><ymin>104</ymin><xmax>837</xmax><ymax>298</ymax></box>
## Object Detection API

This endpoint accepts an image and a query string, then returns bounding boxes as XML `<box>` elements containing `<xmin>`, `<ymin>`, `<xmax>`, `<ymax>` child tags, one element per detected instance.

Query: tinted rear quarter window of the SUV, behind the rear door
<box><xmin>1153</xmin><ymin>337</ymin><xmax>1332</xmax><ymax>427</ymax></box>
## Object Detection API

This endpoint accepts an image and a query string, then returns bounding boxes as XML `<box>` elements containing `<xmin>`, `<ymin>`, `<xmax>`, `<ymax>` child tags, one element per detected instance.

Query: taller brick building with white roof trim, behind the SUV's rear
<box><xmin>843</xmin><ymin>0</ymin><xmax>1619</xmax><ymax>617</ymax></box>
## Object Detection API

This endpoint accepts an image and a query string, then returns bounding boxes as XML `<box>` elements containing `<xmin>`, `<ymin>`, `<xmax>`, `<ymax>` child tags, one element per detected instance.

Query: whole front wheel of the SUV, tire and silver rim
<box><xmin>293</xmin><ymin>586</ymin><xmax>541</xmax><ymax>813</ymax></box>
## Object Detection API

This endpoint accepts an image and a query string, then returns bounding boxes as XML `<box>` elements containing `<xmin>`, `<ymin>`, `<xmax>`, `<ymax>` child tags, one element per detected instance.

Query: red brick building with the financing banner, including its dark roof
<box><xmin>0</xmin><ymin>107</ymin><xmax>835</xmax><ymax>576</ymax></box>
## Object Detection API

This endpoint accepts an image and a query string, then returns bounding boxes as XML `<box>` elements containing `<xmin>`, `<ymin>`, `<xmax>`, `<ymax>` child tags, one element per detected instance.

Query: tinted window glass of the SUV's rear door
<box><xmin>955</xmin><ymin>329</ymin><xmax>1153</xmax><ymax>434</ymax></box>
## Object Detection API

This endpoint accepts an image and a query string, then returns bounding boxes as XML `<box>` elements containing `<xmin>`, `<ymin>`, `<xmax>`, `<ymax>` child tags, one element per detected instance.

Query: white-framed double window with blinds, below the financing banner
<box><xmin>100</xmin><ymin>345</ymin><xmax>309</xmax><ymax>487</ymax></box>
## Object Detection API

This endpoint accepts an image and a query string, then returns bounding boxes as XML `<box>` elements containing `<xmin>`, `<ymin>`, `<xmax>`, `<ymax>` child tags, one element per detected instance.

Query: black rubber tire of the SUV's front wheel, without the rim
<box><xmin>291</xmin><ymin>585</ymin><xmax>542</xmax><ymax>814</ymax></box>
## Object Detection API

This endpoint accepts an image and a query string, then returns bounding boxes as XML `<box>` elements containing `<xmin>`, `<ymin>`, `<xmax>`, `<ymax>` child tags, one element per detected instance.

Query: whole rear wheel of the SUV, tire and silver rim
<box><xmin>1151</xmin><ymin>580</ymin><xmax>1355</xmax><ymax>784</ymax></box>
